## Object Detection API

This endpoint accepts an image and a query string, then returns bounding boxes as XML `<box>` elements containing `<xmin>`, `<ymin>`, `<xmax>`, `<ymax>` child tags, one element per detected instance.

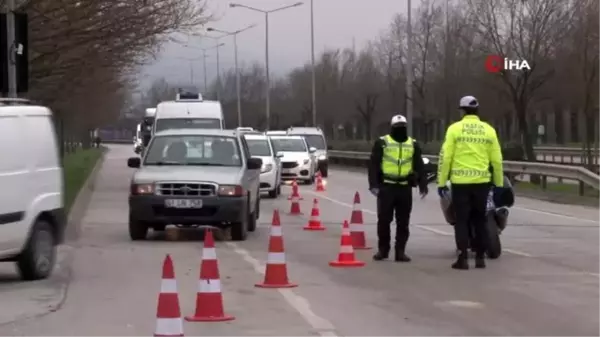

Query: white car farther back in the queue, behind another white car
<box><xmin>270</xmin><ymin>136</ymin><xmax>317</xmax><ymax>184</ymax></box>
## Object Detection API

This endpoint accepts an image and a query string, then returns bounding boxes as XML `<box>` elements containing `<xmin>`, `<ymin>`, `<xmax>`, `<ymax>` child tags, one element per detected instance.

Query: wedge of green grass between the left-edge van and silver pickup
<box><xmin>63</xmin><ymin>148</ymin><xmax>104</xmax><ymax>214</ymax></box>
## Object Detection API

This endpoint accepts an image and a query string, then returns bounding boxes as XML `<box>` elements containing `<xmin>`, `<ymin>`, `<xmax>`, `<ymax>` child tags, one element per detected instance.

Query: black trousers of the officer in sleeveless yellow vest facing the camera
<box><xmin>377</xmin><ymin>184</ymin><xmax>412</xmax><ymax>254</ymax></box>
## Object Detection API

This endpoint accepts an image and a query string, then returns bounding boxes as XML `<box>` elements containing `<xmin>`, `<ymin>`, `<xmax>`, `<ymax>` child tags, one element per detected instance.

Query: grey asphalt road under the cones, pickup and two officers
<box><xmin>0</xmin><ymin>146</ymin><xmax>600</xmax><ymax>337</ymax></box>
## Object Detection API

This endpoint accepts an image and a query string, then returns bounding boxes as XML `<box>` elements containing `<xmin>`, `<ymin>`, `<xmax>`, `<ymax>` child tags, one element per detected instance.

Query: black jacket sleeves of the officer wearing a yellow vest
<box><xmin>369</xmin><ymin>138</ymin><xmax>427</xmax><ymax>191</ymax></box>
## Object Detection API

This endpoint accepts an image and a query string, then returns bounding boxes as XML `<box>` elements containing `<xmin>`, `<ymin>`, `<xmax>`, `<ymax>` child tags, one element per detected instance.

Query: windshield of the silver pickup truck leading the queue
<box><xmin>144</xmin><ymin>136</ymin><xmax>242</xmax><ymax>166</ymax></box>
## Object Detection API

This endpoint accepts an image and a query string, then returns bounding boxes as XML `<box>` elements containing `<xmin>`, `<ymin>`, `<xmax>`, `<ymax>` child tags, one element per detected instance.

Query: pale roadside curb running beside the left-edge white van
<box><xmin>0</xmin><ymin>148</ymin><xmax>107</xmax><ymax>326</ymax></box>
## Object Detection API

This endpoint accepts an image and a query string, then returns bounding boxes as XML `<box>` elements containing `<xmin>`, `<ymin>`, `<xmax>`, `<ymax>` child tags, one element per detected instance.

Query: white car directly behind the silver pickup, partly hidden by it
<box><xmin>244</xmin><ymin>134</ymin><xmax>283</xmax><ymax>198</ymax></box>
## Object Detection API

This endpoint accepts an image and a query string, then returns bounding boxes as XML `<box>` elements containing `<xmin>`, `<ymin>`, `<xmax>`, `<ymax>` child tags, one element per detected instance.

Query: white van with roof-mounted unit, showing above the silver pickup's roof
<box><xmin>152</xmin><ymin>93</ymin><xmax>225</xmax><ymax>134</ymax></box>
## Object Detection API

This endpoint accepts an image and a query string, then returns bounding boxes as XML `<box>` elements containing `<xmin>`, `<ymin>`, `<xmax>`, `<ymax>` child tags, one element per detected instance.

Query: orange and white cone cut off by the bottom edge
<box><xmin>154</xmin><ymin>255</ymin><xmax>183</xmax><ymax>337</ymax></box>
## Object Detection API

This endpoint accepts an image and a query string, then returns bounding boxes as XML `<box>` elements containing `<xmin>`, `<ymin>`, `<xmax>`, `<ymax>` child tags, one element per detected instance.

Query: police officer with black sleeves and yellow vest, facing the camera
<box><xmin>369</xmin><ymin>115</ymin><xmax>428</xmax><ymax>262</ymax></box>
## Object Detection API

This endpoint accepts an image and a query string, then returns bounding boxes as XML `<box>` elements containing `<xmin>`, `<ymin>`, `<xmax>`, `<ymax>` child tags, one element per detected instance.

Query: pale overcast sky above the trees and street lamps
<box><xmin>140</xmin><ymin>0</ymin><xmax>412</xmax><ymax>87</ymax></box>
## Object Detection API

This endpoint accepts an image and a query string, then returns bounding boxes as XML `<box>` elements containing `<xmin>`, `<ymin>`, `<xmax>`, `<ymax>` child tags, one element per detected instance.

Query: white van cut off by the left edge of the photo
<box><xmin>0</xmin><ymin>99</ymin><xmax>66</xmax><ymax>280</ymax></box>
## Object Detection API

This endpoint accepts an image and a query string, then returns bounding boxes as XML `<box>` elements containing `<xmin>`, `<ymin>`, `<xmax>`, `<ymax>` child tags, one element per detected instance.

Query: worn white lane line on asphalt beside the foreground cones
<box><xmin>225</xmin><ymin>242</ymin><xmax>340</xmax><ymax>337</ymax></box>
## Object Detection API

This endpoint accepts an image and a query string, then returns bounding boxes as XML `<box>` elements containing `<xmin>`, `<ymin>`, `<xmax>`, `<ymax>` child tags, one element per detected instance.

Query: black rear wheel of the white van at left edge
<box><xmin>17</xmin><ymin>219</ymin><xmax>56</xmax><ymax>281</ymax></box>
